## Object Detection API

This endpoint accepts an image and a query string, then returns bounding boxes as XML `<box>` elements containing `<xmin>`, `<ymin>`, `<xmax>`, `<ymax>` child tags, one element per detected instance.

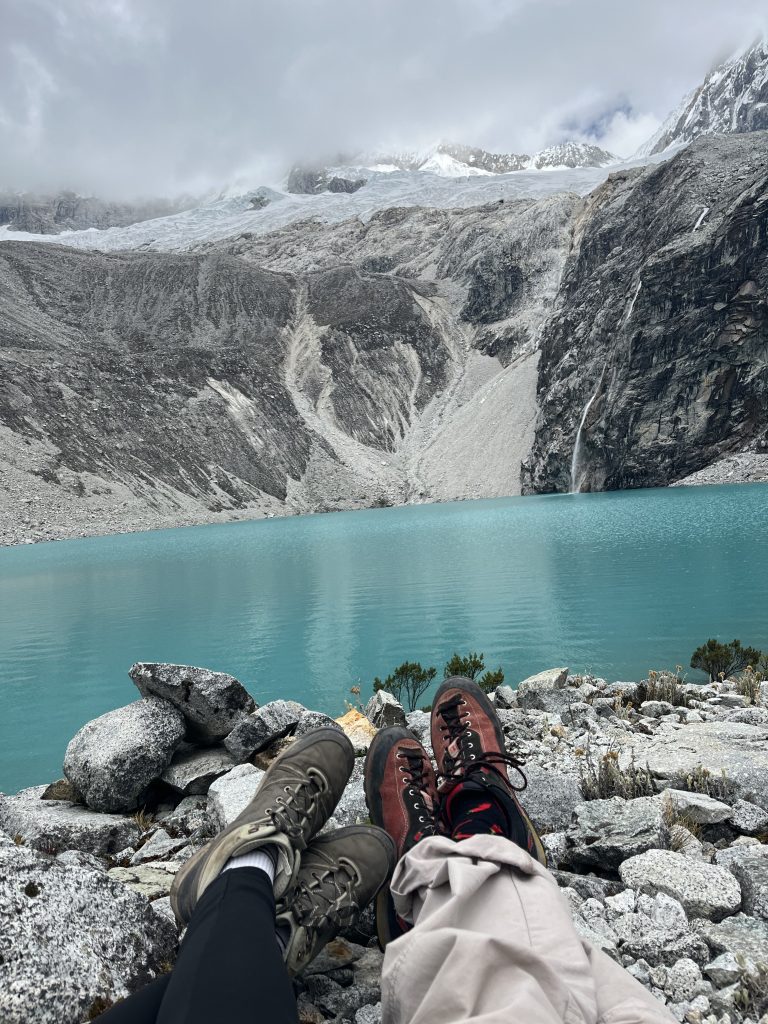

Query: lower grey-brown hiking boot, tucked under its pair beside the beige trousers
<box><xmin>275</xmin><ymin>825</ymin><xmax>395</xmax><ymax>976</ymax></box>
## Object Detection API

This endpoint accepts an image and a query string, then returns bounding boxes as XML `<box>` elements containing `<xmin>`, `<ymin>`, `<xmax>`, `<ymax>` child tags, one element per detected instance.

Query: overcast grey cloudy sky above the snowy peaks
<box><xmin>0</xmin><ymin>0</ymin><xmax>768</xmax><ymax>198</ymax></box>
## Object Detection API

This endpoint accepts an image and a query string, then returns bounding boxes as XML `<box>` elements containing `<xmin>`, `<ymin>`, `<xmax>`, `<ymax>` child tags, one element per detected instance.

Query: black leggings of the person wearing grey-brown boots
<box><xmin>98</xmin><ymin>867</ymin><xmax>299</xmax><ymax>1024</ymax></box>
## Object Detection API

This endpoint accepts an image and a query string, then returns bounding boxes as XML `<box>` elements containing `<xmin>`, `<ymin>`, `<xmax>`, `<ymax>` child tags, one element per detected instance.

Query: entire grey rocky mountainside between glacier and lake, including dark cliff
<box><xmin>0</xmin><ymin>132</ymin><xmax>768</xmax><ymax>543</ymax></box>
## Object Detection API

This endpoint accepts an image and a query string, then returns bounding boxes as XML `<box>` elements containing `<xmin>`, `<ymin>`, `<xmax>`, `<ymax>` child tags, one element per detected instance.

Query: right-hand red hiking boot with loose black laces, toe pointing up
<box><xmin>431</xmin><ymin>676</ymin><xmax>547</xmax><ymax>865</ymax></box>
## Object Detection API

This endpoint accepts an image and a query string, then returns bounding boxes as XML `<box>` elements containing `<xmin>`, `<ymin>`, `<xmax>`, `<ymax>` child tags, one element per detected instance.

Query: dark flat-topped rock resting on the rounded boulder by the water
<box><xmin>128</xmin><ymin>662</ymin><xmax>256</xmax><ymax>743</ymax></box>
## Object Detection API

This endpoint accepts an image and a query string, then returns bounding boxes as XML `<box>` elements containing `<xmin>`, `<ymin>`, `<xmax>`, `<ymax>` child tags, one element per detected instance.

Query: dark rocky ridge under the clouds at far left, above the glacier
<box><xmin>0</xmin><ymin>191</ymin><xmax>193</xmax><ymax>234</ymax></box>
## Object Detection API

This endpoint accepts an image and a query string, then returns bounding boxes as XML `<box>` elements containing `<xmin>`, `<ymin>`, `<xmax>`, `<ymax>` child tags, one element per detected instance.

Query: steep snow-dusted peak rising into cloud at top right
<box><xmin>636</xmin><ymin>40</ymin><xmax>768</xmax><ymax>157</ymax></box>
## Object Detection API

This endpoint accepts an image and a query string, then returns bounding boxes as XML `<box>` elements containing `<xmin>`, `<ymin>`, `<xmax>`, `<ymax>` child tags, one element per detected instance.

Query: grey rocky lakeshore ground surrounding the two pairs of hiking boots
<box><xmin>0</xmin><ymin>664</ymin><xmax>768</xmax><ymax>1024</ymax></box>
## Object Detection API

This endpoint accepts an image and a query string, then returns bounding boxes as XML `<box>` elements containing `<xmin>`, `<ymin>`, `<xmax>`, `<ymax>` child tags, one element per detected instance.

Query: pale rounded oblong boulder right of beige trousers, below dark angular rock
<box><xmin>618</xmin><ymin>850</ymin><xmax>741</xmax><ymax>921</ymax></box>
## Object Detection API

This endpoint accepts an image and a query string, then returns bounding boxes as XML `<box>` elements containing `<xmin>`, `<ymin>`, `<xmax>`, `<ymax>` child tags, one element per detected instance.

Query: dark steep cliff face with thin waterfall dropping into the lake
<box><xmin>523</xmin><ymin>134</ymin><xmax>768</xmax><ymax>492</ymax></box>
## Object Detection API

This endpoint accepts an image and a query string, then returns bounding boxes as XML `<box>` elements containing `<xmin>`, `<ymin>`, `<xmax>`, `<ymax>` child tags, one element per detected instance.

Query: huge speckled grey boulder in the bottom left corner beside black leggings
<box><xmin>0</xmin><ymin>846</ymin><xmax>176</xmax><ymax>1024</ymax></box>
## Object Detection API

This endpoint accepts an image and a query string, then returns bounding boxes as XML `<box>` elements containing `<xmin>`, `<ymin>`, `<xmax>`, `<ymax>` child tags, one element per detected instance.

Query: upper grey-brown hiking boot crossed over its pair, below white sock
<box><xmin>171</xmin><ymin>729</ymin><xmax>354</xmax><ymax>925</ymax></box>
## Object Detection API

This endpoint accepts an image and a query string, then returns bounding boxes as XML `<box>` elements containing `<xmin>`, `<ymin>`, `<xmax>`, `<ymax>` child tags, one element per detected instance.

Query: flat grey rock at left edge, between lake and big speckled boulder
<box><xmin>0</xmin><ymin>785</ymin><xmax>140</xmax><ymax>857</ymax></box>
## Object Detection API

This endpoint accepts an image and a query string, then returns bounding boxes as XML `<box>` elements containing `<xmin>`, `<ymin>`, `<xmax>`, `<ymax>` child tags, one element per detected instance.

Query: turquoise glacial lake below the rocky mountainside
<box><xmin>0</xmin><ymin>484</ymin><xmax>768</xmax><ymax>793</ymax></box>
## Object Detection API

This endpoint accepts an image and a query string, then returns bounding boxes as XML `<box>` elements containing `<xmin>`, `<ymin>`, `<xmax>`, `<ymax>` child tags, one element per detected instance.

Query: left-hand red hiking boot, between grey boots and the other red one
<box><xmin>366</xmin><ymin>725</ymin><xmax>437</xmax><ymax>949</ymax></box>
